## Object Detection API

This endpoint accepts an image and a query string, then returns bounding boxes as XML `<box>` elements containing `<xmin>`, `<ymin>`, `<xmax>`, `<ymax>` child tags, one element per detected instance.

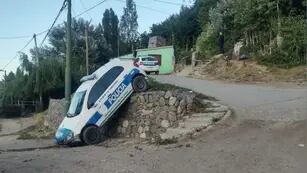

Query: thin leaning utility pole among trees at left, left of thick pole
<box><xmin>33</xmin><ymin>34</ymin><xmax>43</xmax><ymax>110</ymax></box>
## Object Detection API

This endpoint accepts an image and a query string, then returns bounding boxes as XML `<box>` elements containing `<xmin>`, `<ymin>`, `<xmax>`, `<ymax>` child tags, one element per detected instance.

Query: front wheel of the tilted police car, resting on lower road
<box><xmin>82</xmin><ymin>126</ymin><xmax>101</xmax><ymax>145</ymax></box>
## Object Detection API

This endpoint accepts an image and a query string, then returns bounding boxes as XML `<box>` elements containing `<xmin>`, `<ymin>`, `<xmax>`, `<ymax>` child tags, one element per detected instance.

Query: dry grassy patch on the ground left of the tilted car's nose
<box><xmin>18</xmin><ymin>112</ymin><xmax>55</xmax><ymax>139</ymax></box>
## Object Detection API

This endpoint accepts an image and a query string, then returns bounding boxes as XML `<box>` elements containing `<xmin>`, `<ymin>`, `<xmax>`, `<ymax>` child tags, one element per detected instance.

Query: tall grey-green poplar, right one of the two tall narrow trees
<box><xmin>120</xmin><ymin>0</ymin><xmax>138</xmax><ymax>50</ymax></box>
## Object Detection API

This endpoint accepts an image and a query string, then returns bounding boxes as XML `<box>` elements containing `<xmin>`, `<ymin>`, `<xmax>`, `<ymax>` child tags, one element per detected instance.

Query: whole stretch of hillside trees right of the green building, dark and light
<box><xmin>151</xmin><ymin>0</ymin><xmax>307</xmax><ymax>68</ymax></box>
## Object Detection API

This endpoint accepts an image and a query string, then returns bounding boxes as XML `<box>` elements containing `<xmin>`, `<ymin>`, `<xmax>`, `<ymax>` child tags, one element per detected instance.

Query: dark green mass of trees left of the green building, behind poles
<box><xmin>3</xmin><ymin>0</ymin><xmax>144</xmax><ymax>108</ymax></box>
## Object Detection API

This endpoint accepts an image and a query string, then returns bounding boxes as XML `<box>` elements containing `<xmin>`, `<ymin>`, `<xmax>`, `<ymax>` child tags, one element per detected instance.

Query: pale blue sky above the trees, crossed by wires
<box><xmin>0</xmin><ymin>0</ymin><xmax>190</xmax><ymax>78</ymax></box>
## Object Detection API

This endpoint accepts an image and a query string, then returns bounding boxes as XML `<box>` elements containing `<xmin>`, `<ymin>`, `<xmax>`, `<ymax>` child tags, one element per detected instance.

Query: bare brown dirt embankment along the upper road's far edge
<box><xmin>190</xmin><ymin>55</ymin><xmax>307</xmax><ymax>85</ymax></box>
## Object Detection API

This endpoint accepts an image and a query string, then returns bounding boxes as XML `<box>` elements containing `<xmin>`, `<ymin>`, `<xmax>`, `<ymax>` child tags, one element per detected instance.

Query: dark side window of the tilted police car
<box><xmin>87</xmin><ymin>66</ymin><xmax>124</xmax><ymax>109</ymax></box>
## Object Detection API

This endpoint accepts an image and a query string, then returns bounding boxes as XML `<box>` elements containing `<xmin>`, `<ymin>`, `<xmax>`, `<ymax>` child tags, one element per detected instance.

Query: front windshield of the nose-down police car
<box><xmin>67</xmin><ymin>91</ymin><xmax>86</xmax><ymax>117</ymax></box>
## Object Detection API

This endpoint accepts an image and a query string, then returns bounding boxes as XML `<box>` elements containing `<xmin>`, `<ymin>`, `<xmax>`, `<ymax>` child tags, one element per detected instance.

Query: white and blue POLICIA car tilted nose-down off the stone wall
<box><xmin>55</xmin><ymin>59</ymin><xmax>148</xmax><ymax>145</ymax></box>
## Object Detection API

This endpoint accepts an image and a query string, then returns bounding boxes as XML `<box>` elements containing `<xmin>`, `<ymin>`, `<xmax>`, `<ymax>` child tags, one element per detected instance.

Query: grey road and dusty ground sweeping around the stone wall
<box><xmin>0</xmin><ymin>76</ymin><xmax>307</xmax><ymax>173</ymax></box>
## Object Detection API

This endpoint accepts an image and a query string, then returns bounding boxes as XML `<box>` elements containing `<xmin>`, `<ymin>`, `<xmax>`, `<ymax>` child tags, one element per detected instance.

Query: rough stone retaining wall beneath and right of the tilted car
<box><xmin>117</xmin><ymin>90</ymin><xmax>196</xmax><ymax>142</ymax></box>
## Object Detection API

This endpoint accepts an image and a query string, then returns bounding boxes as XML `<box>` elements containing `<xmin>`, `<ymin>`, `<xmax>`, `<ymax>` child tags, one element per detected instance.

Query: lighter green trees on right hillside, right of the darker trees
<box><xmin>197</xmin><ymin>0</ymin><xmax>307</xmax><ymax>68</ymax></box>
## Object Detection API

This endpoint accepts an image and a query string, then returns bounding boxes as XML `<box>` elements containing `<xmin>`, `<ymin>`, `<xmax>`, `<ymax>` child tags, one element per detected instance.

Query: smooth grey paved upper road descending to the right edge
<box><xmin>155</xmin><ymin>76</ymin><xmax>307</xmax><ymax>121</ymax></box>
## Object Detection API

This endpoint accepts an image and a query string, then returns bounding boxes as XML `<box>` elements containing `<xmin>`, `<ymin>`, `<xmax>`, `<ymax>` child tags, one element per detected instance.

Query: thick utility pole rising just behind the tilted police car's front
<box><xmin>65</xmin><ymin>0</ymin><xmax>71</xmax><ymax>104</ymax></box>
